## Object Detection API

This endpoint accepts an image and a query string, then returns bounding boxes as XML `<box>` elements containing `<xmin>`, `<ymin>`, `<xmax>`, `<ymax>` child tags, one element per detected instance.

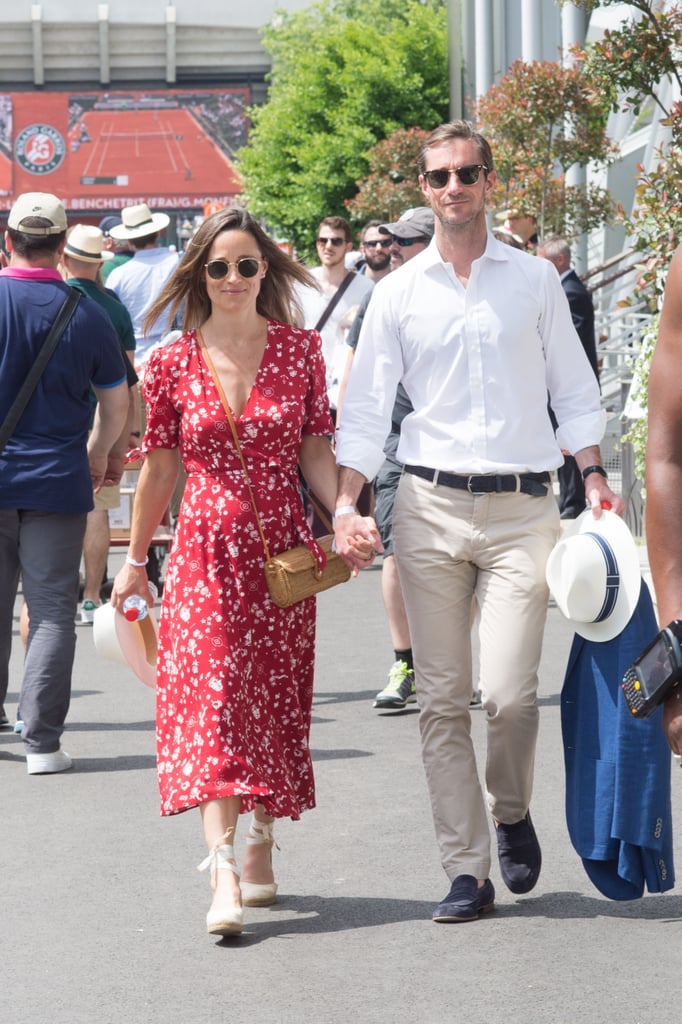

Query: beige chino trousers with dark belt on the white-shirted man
<box><xmin>393</xmin><ymin>474</ymin><xmax>559</xmax><ymax>881</ymax></box>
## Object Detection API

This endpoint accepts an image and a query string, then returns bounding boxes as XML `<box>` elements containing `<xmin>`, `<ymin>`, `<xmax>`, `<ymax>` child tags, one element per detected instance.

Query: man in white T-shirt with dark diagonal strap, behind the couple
<box><xmin>296</xmin><ymin>217</ymin><xmax>374</xmax><ymax>411</ymax></box>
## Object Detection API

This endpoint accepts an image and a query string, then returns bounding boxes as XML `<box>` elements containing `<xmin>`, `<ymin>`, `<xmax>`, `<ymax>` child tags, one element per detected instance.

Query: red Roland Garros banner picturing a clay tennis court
<box><xmin>0</xmin><ymin>88</ymin><xmax>246</xmax><ymax>216</ymax></box>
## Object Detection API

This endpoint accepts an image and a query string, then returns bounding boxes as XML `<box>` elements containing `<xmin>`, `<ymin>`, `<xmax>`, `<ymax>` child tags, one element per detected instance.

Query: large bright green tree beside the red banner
<box><xmin>238</xmin><ymin>0</ymin><xmax>449</xmax><ymax>255</ymax></box>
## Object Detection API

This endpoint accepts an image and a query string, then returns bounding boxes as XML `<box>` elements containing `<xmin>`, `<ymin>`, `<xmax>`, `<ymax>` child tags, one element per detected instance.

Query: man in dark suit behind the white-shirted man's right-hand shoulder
<box><xmin>538</xmin><ymin>236</ymin><xmax>599</xmax><ymax>519</ymax></box>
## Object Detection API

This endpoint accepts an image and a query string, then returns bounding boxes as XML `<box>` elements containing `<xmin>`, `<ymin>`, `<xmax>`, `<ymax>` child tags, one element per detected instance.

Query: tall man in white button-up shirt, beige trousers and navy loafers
<box><xmin>336</xmin><ymin>121</ymin><xmax>625</xmax><ymax>922</ymax></box>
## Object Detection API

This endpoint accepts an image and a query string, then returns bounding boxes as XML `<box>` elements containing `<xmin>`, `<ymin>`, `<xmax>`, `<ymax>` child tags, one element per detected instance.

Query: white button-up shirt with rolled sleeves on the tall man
<box><xmin>336</xmin><ymin>234</ymin><xmax>606</xmax><ymax>479</ymax></box>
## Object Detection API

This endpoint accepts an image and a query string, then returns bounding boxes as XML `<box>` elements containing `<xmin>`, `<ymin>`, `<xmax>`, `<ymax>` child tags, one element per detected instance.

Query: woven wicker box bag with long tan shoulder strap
<box><xmin>199</xmin><ymin>335</ymin><xmax>350</xmax><ymax>608</ymax></box>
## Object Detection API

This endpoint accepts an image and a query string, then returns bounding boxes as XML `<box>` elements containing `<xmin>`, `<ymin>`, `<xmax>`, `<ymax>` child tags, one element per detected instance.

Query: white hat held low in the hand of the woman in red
<box><xmin>92</xmin><ymin>602</ymin><xmax>159</xmax><ymax>687</ymax></box>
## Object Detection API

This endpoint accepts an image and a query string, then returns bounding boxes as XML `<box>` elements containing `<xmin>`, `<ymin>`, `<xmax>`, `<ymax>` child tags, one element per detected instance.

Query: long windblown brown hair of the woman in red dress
<box><xmin>144</xmin><ymin>207</ymin><xmax>318</xmax><ymax>332</ymax></box>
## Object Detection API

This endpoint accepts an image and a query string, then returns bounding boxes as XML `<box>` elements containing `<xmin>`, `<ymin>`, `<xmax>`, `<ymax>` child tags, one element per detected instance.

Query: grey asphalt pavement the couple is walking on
<box><xmin>0</xmin><ymin>555</ymin><xmax>682</xmax><ymax>1024</ymax></box>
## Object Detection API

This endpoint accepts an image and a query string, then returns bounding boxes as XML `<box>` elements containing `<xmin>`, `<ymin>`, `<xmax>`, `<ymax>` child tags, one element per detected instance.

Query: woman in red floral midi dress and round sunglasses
<box><xmin>112</xmin><ymin>209</ymin><xmax>372</xmax><ymax>935</ymax></box>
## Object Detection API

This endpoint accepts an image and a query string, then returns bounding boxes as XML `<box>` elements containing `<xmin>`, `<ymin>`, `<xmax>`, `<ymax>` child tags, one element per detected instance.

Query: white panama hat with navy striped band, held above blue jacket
<box><xmin>546</xmin><ymin>509</ymin><xmax>642</xmax><ymax>641</ymax></box>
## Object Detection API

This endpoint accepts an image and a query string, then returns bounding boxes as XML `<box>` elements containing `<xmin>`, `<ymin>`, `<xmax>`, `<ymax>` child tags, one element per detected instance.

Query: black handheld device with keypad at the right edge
<box><xmin>621</xmin><ymin>618</ymin><xmax>682</xmax><ymax>718</ymax></box>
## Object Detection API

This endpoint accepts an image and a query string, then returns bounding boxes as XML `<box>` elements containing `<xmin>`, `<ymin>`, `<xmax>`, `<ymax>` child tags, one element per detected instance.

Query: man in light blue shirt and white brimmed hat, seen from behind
<box><xmin>106</xmin><ymin>203</ymin><xmax>178</xmax><ymax>373</ymax></box>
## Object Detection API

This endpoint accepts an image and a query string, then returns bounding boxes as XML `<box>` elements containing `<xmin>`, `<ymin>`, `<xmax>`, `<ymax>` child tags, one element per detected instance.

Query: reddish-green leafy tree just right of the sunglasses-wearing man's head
<box><xmin>477</xmin><ymin>60</ymin><xmax>615</xmax><ymax>238</ymax></box>
